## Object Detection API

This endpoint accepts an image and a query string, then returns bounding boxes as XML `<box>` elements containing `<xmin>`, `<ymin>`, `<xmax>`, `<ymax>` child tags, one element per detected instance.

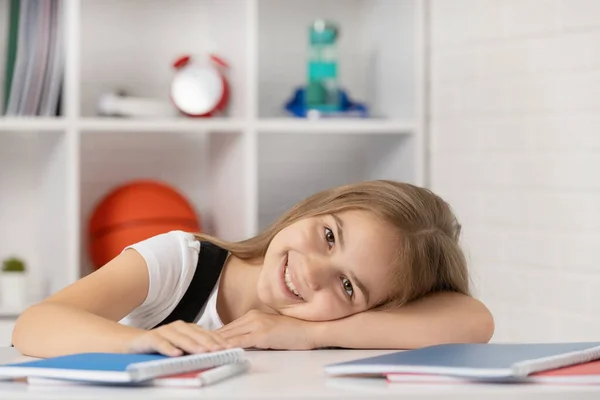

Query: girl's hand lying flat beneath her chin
<box><xmin>216</xmin><ymin>310</ymin><xmax>318</xmax><ymax>350</ymax></box>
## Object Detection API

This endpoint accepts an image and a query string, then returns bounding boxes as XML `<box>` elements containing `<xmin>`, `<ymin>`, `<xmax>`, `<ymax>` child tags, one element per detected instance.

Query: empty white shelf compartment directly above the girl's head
<box><xmin>258</xmin><ymin>132</ymin><xmax>417</xmax><ymax>229</ymax></box>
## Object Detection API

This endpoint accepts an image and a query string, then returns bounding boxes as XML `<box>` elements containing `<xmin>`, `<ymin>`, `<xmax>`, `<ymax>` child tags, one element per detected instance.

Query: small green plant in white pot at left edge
<box><xmin>0</xmin><ymin>257</ymin><xmax>27</xmax><ymax>312</ymax></box>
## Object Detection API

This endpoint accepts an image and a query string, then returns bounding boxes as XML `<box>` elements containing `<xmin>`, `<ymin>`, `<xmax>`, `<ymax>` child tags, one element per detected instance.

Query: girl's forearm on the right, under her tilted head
<box><xmin>313</xmin><ymin>293</ymin><xmax>494</xmax><ymax>349</ymax></box>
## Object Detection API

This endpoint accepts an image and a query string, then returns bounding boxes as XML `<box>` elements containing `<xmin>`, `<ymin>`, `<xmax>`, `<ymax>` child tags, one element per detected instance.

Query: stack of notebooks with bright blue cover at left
<box><xmin>0</xmin><ymin>348</ymin><xmax>249</xmax><ymax>387</ymax></box>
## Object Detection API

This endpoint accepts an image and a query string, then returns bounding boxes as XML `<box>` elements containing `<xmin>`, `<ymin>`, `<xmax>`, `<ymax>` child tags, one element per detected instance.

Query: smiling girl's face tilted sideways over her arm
<box><xmin>258</xmin><ymin>210</ymin><xmax>399</xmax><ymax>321</ymax></box>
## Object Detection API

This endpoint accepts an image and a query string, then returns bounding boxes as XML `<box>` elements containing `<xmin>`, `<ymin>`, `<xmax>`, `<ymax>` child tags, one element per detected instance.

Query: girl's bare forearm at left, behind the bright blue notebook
<box><xmin>12</xmin><ymin>303</ymin><xmax>144</xmax><ymax>357</ymax></box>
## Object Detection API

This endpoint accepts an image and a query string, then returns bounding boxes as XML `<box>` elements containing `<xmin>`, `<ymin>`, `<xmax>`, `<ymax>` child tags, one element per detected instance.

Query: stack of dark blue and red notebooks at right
<box><xmin>325</xmin><ymin>342</ymin><xmax>600</xmax><ymax>384</ymax></box>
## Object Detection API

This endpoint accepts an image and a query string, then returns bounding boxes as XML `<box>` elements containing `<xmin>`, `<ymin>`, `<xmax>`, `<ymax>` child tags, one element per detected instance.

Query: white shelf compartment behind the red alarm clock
<box><xmin>80</xmin><ymin>0</ymin><xmax>248</xmax><ymax>117</ymax></box>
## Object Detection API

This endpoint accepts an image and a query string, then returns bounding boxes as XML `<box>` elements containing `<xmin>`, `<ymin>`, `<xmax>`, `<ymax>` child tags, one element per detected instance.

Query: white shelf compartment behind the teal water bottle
<box><xmin>258</xmin><ymin>0</ymin><xmax>420</xmax><ymax>119</ymax></box>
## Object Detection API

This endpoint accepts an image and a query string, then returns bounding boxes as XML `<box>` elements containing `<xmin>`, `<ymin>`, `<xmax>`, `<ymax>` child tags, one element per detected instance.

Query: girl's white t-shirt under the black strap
<box><xmin>120</xmin><ymin>231</ymin><xmax>223</xmax><ymax>330</ymax></box>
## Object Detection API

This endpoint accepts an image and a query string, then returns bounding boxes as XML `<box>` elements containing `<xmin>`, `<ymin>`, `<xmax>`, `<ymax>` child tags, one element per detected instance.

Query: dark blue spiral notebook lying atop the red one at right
<box><xmin>325</xmin><ymin>342</ymin><xmax>600</xmax><ymax>379</ymax></box>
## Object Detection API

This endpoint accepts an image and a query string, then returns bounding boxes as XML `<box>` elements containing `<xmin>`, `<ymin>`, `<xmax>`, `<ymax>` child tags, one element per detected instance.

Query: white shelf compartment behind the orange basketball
<box><xmin>80</xmin><ymin>131</ymin><xmax>249</xmax><ymax>275</ymax></box>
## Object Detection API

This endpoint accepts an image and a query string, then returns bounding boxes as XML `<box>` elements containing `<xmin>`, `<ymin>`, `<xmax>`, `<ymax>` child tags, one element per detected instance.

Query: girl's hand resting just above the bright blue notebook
<box><xmin>126</xmin><ymin>321</ymin><xmax>233</xmax><ymax>357</ymax></box>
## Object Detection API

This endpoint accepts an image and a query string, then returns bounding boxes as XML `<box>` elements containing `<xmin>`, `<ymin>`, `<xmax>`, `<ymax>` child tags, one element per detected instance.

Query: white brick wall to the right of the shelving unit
<box><xmin>430</xmin><ymin>0</ymin><xmax>600</xmax><ymax>341</ymax></box>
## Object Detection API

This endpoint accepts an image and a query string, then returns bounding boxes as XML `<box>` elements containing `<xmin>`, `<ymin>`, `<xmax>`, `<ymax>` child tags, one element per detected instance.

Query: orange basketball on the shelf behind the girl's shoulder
<box><xmin>88</xmin><ymin>180</ymin><xmax>201</xmax><ymax>268</ymax></box>
